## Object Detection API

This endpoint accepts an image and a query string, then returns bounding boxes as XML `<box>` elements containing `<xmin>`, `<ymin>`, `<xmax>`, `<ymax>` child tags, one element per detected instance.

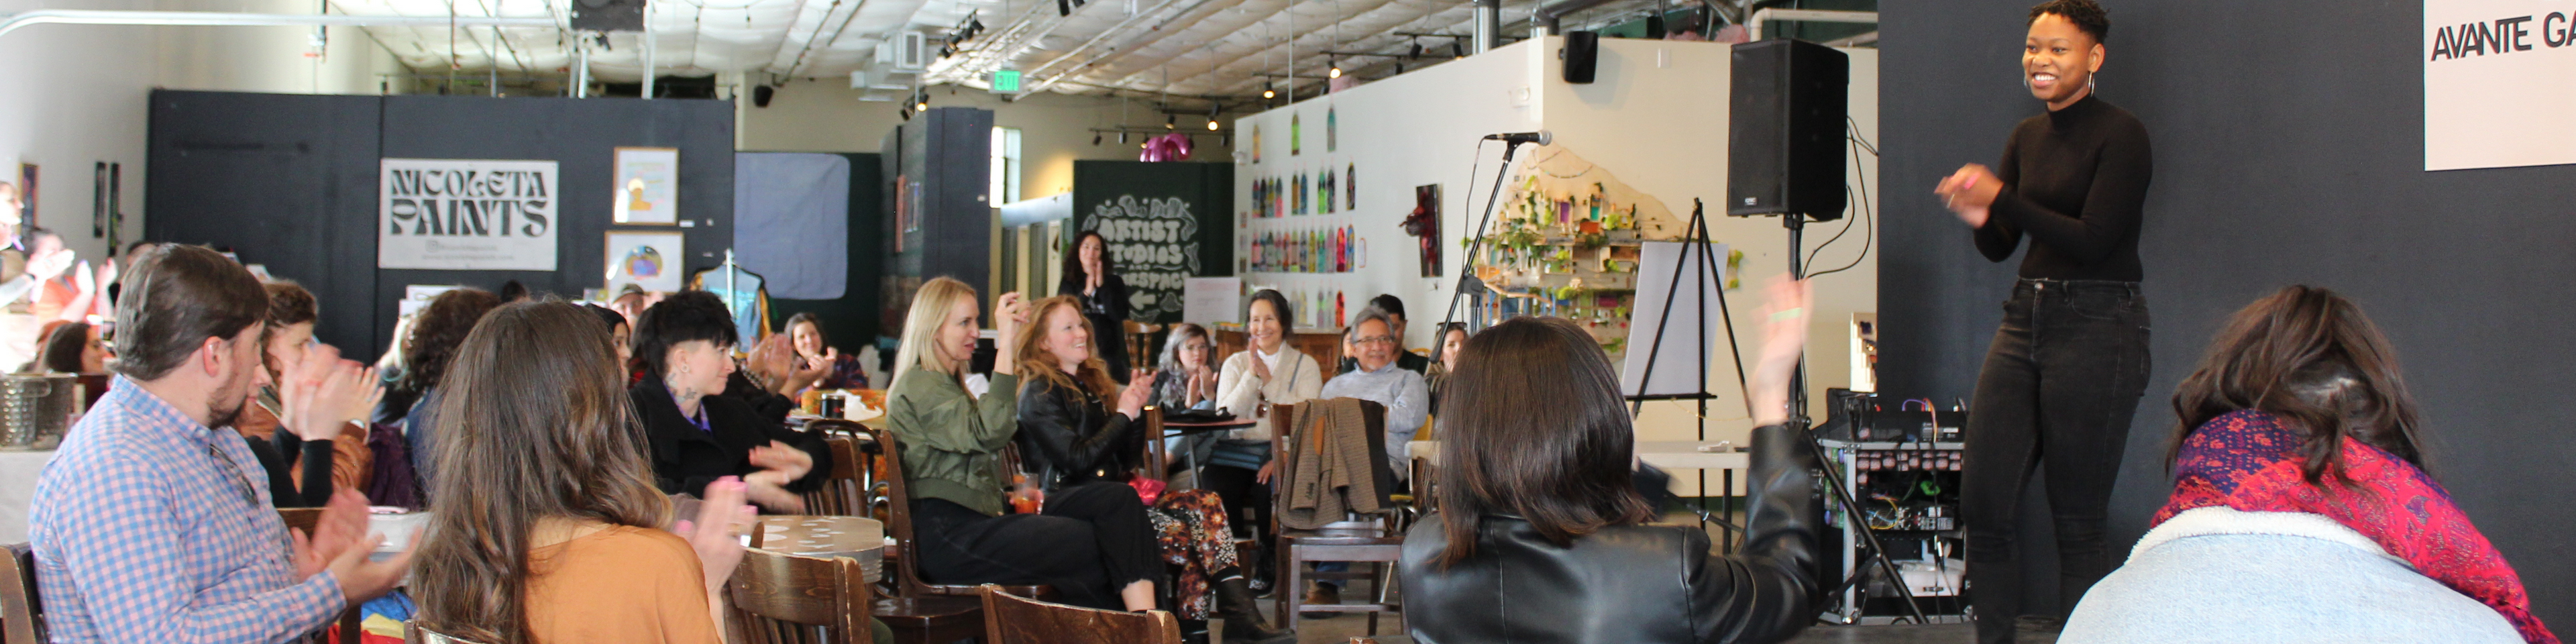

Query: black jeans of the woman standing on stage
<box><xmin>1960</xmin><ymin>278</ymin><xmax>2149</xmax><ymax>641</ymax></box>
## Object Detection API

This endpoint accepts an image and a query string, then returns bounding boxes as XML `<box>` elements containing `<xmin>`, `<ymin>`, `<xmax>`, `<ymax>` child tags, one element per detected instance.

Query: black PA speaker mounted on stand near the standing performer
<box><xmin>1726</xmin><ymin>39</ymin><xmax>1852</xmax><ymax>221</ymax></box>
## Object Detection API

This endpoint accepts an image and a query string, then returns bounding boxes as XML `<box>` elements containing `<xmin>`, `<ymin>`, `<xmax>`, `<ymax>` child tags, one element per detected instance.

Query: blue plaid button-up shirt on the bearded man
<box><xmin>28</xmin><ymin>376</ymin><xmax>345</xmax><ymax>644</ymax></box>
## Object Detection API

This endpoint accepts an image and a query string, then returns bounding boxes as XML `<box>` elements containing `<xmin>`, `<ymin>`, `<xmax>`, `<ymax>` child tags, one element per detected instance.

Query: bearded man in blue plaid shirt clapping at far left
<box><xmin>28</xmin><ymin>245</ymin><xmax>410</xmax><ymax>644</ymax></box>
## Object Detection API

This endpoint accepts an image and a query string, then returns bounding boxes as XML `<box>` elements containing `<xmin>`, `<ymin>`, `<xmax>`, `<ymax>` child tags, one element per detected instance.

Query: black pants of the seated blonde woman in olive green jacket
<box><xmin>912</xmin><ymin>482</ymin><xmax>1162</xmax><ymax>610</ymax></box>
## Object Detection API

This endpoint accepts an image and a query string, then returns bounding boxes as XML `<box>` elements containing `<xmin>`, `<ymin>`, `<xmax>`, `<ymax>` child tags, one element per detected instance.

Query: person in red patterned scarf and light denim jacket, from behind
<box><xmin>2058</xmin><ymin>286</ymin><xmax>2558</xmax><ymax>644</ymax></box>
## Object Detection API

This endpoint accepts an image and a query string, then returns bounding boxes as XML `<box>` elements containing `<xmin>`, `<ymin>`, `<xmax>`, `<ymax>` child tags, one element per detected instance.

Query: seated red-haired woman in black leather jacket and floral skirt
<box><xmin>1012</xmin><ymin>297</ymin><xmax>1280</xmax><ymax>639</ymax></box>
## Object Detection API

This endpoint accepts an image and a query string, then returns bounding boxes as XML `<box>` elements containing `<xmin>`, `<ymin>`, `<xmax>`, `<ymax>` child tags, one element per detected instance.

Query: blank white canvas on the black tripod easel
<box><xmin>1618</xmin><ymin>242</ymin><xmax>1726</xmax><ymax>396</ymax></box>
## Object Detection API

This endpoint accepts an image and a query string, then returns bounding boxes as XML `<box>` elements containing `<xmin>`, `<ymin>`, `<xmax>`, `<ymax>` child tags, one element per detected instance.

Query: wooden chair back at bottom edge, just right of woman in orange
<box><xmin>724</xmin><ymin>549</ymin><xmax>876</xmax><ymax>644</ymax></box>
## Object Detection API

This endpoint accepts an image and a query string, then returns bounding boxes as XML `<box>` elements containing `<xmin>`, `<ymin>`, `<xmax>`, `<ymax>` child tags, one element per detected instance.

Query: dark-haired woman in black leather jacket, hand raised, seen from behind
<box><xmin>1401</xmin><ymin>283</ymin><xmax>1824</xmax><ymax>644</ymax></box>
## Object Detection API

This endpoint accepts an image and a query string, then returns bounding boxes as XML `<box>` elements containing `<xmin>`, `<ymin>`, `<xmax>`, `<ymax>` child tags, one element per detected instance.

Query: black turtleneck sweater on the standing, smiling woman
<box><xmin>1976</xmin><ymin>95</ymin><xmax>2156</xmax><ymax>281</ymax></box>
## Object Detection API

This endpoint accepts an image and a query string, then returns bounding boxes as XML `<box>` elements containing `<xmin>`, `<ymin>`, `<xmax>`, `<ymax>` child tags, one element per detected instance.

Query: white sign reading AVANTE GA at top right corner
<box><xmin>2416</xmin><ymin>0</ymin><xmax>2576</xmax><ymax>170</ymax></box>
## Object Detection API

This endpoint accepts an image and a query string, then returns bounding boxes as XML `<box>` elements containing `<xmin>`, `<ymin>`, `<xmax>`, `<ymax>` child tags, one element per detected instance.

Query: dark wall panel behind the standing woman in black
<box><xmin>1880</xmin><ymin>0</ymin><xmax>2576</xmax><ymax>623</ymax></box>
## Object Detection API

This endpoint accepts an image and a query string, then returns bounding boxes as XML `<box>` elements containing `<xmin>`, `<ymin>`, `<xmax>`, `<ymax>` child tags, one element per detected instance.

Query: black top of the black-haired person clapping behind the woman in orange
<box><xmin>626</xmin><ymin>378</ymin><xmax>832</xmax><ymax>497</ymax></box>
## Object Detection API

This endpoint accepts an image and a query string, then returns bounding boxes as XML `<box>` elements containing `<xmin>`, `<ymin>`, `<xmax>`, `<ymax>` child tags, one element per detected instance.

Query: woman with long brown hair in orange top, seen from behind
<box><xmin>410</xmin><ymin>301</ymin><xmax>752</xmax><ymax>644</ymax></box>
